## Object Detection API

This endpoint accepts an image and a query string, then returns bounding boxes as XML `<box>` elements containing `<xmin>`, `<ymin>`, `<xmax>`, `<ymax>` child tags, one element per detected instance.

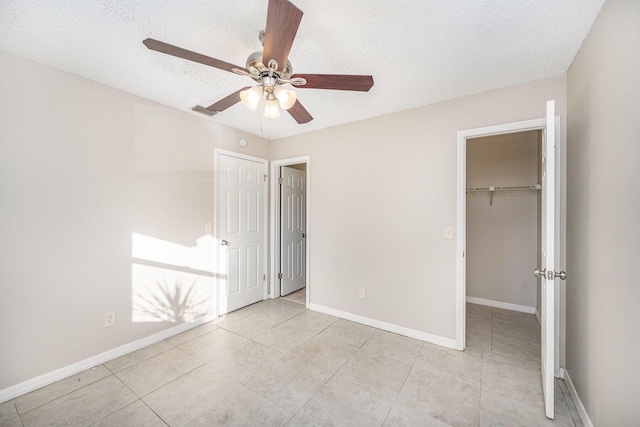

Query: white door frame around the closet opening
<box><xmin>456</xmin><ymin>116</ymin><xmax>565</xmax><ymax>378</ymax></box>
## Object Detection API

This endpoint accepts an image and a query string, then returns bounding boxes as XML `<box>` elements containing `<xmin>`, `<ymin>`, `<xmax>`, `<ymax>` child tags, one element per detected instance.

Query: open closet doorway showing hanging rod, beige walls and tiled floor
<box><xmin>465</xmin><ymin>130</ymin><xmax>542</xmax><ymax>363</ymax></box>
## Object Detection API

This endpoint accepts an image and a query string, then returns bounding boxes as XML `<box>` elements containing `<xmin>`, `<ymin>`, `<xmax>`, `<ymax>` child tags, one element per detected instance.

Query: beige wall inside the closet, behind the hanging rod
<box><xmin>466</xmin><ymin>131</ymin><xmax>540</xmax><ymax>312</ymax></box>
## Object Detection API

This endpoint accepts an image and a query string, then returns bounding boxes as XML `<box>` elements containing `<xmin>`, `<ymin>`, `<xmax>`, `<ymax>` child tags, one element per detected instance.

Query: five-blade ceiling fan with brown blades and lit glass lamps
<box><xmin>143</xmin><ymin>0</ymin><xmax>373</xmax><ymax>124</ymax></box>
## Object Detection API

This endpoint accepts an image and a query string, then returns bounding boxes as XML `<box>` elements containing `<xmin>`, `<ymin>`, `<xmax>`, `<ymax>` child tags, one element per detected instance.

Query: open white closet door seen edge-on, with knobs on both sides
<box><xmin>534</xmin><ymin>101</ymin><xmax>566</xmax><ymax>419</ymax></box>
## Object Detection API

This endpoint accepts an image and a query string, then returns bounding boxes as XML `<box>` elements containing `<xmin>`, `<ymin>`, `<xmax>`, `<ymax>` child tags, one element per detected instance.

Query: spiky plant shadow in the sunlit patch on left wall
<box><xmin>132</xmin><ymin>278</ymin><xmax>211</xmax><ymax>323</ymax></box>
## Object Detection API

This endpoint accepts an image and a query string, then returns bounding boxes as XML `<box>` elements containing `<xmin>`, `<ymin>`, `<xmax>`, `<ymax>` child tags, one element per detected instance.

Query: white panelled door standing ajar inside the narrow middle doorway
<box><xmin>280</xmin><ymin>166</ymin><xmax>306</xmax><ymax>295</ymax></box>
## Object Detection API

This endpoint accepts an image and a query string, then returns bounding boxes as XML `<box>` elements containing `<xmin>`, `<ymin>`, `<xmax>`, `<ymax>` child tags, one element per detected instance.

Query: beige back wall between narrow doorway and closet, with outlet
<box><xmin>271</xmin><ymin>76</ymin><xmax>565</xmax><ymax>340</ymax></box>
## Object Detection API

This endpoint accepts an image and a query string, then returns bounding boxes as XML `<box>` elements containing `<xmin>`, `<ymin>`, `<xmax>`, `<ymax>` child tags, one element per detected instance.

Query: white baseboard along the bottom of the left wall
<box><xmin>0</xmin><ymin>316</ymin><xmax>215</xmax><ymax>403</ymax></box>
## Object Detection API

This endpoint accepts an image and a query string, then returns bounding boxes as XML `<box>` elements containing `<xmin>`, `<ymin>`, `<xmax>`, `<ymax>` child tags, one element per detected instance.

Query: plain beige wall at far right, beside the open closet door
<box><xmin>566</xmin><ymin>0</ymin><xmax>640</xmax><ymax>426</ymax></box>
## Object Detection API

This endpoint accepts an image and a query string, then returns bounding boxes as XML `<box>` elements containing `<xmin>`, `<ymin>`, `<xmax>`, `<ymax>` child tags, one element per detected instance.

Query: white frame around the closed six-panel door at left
<box><xmin>213</xmin><ymin>148</ymin><xmax>269</xmax><ymax>317</ymax></box>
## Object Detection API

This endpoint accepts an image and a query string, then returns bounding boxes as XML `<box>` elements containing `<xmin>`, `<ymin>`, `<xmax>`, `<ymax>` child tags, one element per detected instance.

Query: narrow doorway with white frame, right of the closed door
<box><xmin>270</xmin><ymin>156</ymin><xmax>311</xmax><ymax>307</ymax></box>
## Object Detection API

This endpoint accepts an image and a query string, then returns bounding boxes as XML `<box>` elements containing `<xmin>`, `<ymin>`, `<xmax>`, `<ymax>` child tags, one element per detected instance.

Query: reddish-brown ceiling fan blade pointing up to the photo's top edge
<box><xmin>262</xmin><ymin>0</ymin><xmax>302</xmax><ymax>71</ymax></box>
